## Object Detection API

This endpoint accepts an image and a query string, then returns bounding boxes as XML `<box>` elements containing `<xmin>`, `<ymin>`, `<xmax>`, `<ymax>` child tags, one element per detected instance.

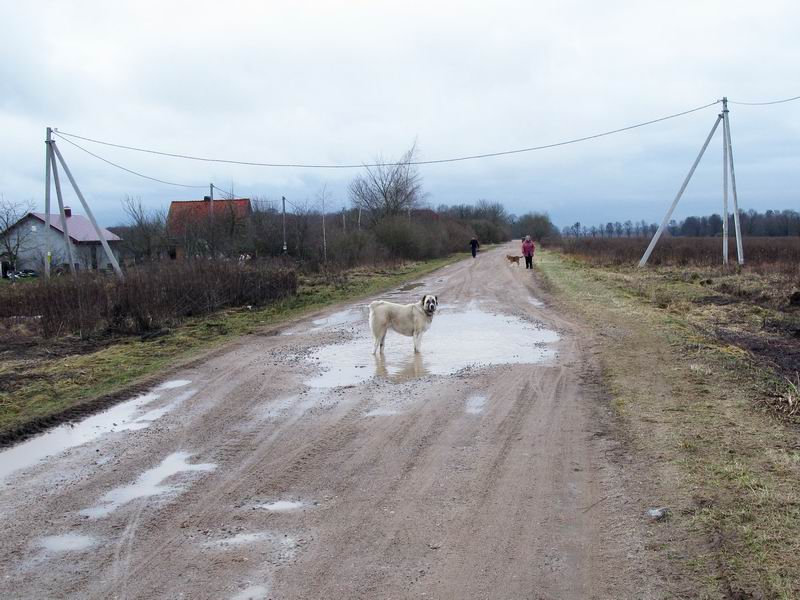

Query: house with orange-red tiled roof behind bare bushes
<box><xmin>167</xmin><ymin>196</ymin><xmax>253</xmax><ymax>258</ymax></box>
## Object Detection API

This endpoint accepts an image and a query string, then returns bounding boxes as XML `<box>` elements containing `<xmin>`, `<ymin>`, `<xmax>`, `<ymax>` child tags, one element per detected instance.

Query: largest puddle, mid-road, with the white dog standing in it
<box><xmin>305</xmin><ymin>304</ymin><xmax>559</xmax><ymax>388</ymax></box>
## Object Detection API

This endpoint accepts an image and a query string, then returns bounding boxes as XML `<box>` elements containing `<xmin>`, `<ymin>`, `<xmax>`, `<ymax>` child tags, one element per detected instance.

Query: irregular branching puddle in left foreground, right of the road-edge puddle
<box><xmin>80</xmin><ymin>452</ymin><xmax>216</xmax><ymax>518</ymax></box>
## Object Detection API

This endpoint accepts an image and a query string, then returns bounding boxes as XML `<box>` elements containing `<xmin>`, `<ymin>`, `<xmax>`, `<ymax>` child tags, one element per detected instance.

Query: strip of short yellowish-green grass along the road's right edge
<box><xmin>539</xmin><ymin>252</ymin><xmax>800</xmax><ymax>600</ymax></box>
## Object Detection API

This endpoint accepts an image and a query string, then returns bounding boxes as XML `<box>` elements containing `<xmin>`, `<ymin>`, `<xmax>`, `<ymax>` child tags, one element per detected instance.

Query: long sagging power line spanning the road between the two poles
<box><xmin>54</xmin><ymin>100</ymin><xmax>720</xmax><ymax>169</ymax></box>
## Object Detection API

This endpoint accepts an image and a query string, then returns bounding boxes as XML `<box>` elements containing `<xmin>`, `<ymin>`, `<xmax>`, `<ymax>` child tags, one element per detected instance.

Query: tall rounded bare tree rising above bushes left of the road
<box><xmin>349</xmin><ymin>143</ymin><xmax>423</xmax><ymax>221</ymax></box>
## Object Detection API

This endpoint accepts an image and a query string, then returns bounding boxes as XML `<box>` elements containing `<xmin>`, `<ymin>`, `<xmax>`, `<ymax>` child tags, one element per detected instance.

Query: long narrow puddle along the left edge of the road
<box><xmin>0</xmin><ymin>379</ymin><xmax>196</xmax><ymax>481</ymax></box>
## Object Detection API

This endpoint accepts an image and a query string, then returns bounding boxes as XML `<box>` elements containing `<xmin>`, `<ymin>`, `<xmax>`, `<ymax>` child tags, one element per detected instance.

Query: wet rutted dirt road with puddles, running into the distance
<box><xmin>0</xmin><ymin>248</ymin><xmax>657</xmax><ymax>599</ymax></box>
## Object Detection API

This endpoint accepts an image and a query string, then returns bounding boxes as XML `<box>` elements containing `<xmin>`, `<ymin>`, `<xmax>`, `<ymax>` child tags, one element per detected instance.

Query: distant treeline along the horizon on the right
<box><xmin>561</xmin><ymin>209</ymin><xmax>800</xmax><ymax>238</ymax></box>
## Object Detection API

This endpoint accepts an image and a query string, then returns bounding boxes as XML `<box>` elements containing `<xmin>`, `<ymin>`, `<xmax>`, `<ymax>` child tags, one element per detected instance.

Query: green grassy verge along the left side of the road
<box><xmin>0</xmin><ymin>254</ymin><xmax>467</xmax><ymax>443</ymax></box>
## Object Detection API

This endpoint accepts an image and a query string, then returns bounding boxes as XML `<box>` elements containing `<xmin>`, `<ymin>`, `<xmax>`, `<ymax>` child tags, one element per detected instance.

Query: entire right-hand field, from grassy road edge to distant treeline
<box><xmin>539</xmin><ymin>246</ymin><xmax>800</xmax><ymax>599</ymax></box>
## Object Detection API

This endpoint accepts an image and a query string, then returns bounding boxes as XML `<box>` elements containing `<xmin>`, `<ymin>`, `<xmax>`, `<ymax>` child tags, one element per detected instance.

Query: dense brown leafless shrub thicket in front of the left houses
<box><xmin>0</xmin><ymin>260</ymin><xmax>297</xmax><ymax>338</ymax></box>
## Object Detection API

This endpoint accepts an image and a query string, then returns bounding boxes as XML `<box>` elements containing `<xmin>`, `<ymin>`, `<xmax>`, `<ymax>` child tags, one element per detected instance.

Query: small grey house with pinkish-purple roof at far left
<box><xmin>0</xmin><ymin>207</ymin><xmax>122</xmax><ymax>272</ymax></box>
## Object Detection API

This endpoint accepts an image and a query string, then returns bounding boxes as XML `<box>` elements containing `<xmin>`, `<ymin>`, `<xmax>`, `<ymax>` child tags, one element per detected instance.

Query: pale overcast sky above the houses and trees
<box><xmin>0</xmin><ymin>0</ymin><xmax>800</xmax><ymax>225</ymax></box>
